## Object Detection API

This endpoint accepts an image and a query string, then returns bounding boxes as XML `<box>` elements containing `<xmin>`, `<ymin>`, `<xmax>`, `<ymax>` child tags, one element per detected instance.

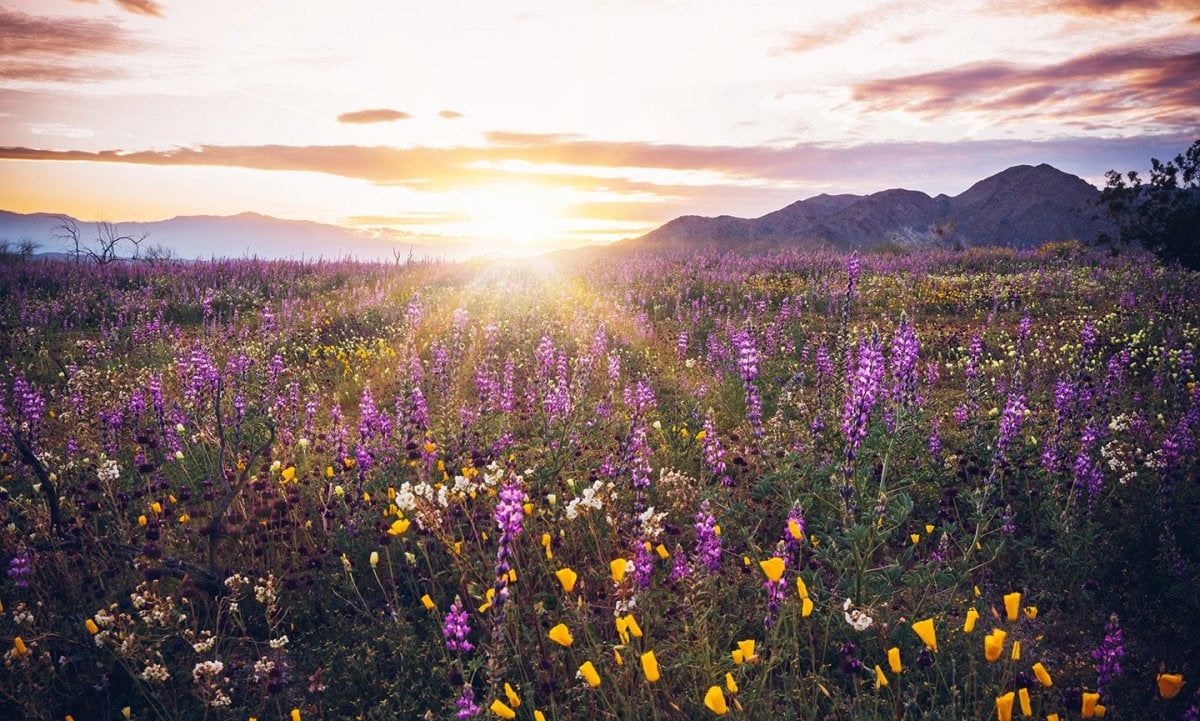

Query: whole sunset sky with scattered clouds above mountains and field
<box><xmin>0</xmin><ymin>0</ymin><xmax>1200</xmax><ymax>254</ymax></box>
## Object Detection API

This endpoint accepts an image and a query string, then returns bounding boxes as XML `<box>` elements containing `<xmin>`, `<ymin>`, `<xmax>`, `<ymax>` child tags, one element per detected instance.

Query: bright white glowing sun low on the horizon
<box><xmin>464</xmin><ymin>186</ymin><xmax>571</xmax><ymax>254</ymax></box>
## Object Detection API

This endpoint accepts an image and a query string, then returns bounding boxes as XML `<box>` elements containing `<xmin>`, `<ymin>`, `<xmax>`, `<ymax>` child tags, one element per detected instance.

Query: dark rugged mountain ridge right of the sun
<box><xmin>616</xmin><ymin>163</ymin><xmax>1111</xmax><ymax>253</ymax></box>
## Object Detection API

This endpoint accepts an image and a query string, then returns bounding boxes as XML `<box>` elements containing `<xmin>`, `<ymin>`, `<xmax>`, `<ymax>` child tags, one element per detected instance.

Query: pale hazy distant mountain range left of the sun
<box><xmin>0</xmin><ymin>210</ymin><xmax>455</xmax><ymax>260</ymax></box>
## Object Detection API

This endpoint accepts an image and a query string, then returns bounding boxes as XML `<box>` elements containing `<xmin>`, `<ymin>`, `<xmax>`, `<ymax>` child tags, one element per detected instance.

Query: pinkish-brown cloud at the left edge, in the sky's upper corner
<box><xmin>0</xmin><ymin>7</ymin><xmax>136</xmax><ymax>83</ymax></box>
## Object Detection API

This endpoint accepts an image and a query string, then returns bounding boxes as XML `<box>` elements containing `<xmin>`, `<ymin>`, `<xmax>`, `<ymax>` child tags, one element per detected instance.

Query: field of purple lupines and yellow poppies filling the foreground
<box><xmin>0</xmin><ymin>245</ymin><xmax>1200</xmax><ymax>721</ymax></box>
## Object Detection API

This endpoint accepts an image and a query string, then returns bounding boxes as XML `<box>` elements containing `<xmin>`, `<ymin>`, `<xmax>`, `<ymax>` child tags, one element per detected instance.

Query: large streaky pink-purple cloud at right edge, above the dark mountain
<box><xmin>851</xmin><ymin>38</ymin><xmax>1200</xmax><ymax>131</ymax></box>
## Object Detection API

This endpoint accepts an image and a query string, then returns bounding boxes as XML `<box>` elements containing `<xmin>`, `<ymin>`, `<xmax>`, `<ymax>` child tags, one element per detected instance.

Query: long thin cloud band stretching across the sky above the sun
<box><xmin>7</xmin><ymin>132</ymin><xmax>1193</xmax><ymax>197</ymax></box>
